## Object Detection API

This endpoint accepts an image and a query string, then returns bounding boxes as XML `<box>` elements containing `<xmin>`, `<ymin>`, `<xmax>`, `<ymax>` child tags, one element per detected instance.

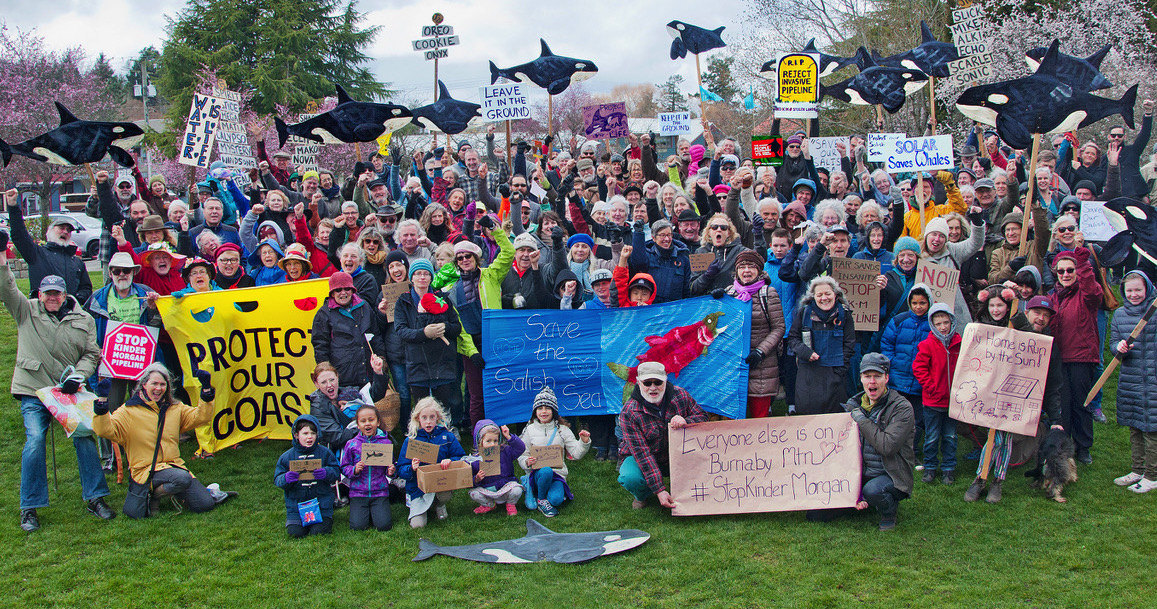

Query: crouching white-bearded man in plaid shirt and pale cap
<box><xmin>619</xmin><ymin>361</ymin><xmax>707</xmax><ymax>509</ymax></box>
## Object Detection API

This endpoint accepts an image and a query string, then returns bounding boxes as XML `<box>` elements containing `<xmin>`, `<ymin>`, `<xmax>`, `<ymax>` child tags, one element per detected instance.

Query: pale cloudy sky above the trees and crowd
<box><xmin>0</xmin><ymin>0</ymin><xmax>744</xmax><ymax>103</ymax></box>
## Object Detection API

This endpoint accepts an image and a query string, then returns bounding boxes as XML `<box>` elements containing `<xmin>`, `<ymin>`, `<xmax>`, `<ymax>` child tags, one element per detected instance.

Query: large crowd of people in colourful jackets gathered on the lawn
<box><xmin>0</xmin><ymin>101</ymin><xmax>1157</xmax><ymax>536</ymax></box>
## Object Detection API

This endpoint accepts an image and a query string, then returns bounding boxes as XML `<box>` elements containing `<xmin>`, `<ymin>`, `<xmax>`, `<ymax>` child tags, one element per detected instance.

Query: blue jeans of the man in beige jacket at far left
<box><xmin>20</xmin><ymin>396</ymin><xmax>109</xmax><ymax>509</ymax></box>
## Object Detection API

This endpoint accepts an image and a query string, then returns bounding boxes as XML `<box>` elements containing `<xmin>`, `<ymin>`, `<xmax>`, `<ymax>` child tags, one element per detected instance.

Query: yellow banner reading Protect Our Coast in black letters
<box><xmin>156</xmin><ymin>279</ymin><xmax>329</xmax><ymax>453</ymax></box>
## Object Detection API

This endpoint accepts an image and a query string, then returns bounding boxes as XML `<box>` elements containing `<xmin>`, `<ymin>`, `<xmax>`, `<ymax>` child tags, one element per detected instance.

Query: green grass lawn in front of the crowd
<box><xmin>0</xmin><ymin>277</ymin><xmax>1157</xmax><ymax>608</ymax></box>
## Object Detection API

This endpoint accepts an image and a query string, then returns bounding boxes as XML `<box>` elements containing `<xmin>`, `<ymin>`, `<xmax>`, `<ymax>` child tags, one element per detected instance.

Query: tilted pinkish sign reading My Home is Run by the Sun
<box><xmin>948</xmin><ymin>323</ymin><xmax>1053</xmax><ymax>435</ymax></box>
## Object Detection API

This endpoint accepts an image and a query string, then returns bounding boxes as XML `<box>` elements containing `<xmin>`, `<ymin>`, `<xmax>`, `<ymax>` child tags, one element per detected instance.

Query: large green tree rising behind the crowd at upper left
<box><xmin>159</xmin><ymin>0</ymin><xmax>392</xmax><ymax>129</ymax></box>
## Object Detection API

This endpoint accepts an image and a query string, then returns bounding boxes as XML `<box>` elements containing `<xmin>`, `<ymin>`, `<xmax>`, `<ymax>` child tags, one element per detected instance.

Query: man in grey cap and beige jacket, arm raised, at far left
<box><xmin>0</xmin><ymin>238</ymin><xmax>117</xmax><ymax>533</ymax></box>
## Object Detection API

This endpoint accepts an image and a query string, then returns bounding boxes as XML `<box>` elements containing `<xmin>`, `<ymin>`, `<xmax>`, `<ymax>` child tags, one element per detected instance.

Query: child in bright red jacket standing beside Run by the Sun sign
<box><xmin>912</xmin><ymin>302</ymin><xmax>960</xmax><ymax>484</ymax></box>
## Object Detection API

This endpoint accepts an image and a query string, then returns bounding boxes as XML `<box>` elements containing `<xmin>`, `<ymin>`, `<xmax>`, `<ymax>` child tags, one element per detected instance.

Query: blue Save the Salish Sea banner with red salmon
<box><xmin>482</xmin><ymin>296</ymin><xmax>751</xmax><ymax>424</ymax></box>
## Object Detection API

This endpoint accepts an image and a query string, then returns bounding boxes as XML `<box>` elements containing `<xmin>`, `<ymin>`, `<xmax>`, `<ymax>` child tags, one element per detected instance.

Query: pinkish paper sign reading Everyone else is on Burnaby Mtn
<box><xmin>669</xmin><ymin>412</ymin><xmax>861</xmax><ymax>516</ymax></box>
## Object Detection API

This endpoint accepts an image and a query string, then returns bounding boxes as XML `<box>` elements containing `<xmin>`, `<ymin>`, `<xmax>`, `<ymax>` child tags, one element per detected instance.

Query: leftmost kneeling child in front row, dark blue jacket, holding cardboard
<box><xmin>273</xmin><ymin>414</ymin><xmax>341</xmax><ymax>538</ymax></box>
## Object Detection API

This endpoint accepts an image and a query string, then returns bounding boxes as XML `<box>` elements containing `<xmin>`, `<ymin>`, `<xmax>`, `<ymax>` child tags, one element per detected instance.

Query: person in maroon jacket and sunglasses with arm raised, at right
<box><xmin>1049</xmin><ymin>245</ymin><xmax>1103</xmax><ymax>465</ymax></box>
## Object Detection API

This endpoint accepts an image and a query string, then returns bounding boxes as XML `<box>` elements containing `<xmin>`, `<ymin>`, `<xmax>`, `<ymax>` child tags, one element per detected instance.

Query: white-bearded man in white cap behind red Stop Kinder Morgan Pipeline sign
<box><xmin>84</xmin><ymin>251</ymin><xmax>161</xmax><ymax>469</ymax></box>
